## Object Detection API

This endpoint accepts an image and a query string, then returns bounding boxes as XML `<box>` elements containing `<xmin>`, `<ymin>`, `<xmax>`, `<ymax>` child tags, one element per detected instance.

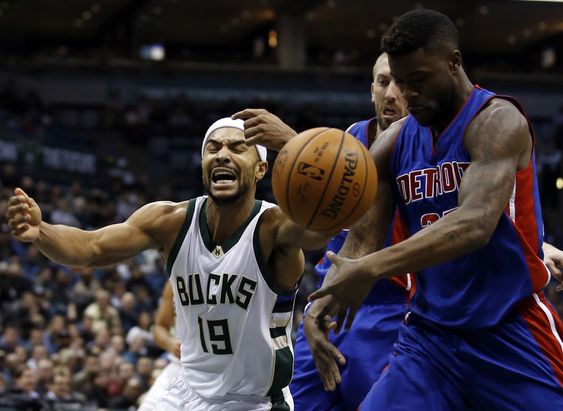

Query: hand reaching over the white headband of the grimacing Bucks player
<box><xmin>232</xmin><ymin>108</ymin><xmax>297</xmax><ymax>151</ymax></box>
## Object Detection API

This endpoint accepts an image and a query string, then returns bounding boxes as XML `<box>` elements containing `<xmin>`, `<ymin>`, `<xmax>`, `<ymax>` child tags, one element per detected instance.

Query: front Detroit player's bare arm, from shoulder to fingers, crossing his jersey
<box><xmin>310</xmin><ymin>100</ymin><xmax>532</xmax><ymax>318</ymax></box>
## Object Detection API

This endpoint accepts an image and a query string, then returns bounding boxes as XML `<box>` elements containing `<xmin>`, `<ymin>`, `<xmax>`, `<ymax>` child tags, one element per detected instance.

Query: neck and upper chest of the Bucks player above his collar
<box><xmin>205</xmin><ymin>193</ymin><xmax>254</xmax><ymax>244</ymax></box>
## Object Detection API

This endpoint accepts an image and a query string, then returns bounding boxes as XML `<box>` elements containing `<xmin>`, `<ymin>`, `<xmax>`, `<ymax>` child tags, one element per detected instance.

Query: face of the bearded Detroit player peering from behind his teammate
<box><xmin>371</xmin><ymin>53</ymin><xmax>408</xmax><ymax>131</ymax></box>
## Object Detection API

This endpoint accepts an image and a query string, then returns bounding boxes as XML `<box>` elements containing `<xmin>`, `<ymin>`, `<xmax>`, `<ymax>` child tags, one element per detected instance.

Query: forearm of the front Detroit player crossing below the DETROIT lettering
<box><xmin>360</xmin><ymin>209</ymin><xmax>490</xmax><ymax>280</ymax></box>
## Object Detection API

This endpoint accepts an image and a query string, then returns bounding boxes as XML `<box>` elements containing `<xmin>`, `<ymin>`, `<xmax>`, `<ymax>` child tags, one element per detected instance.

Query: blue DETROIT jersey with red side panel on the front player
<box><xmin>391</xmin><ymin>86</ymin><xmax>549</xmax><ymax>328</ymax></box>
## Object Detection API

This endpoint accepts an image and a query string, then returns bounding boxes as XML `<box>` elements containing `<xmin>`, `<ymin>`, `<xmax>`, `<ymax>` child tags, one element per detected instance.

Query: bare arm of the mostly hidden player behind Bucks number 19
<box><xmin>152</xmin><ymin>281</ymin><xmax>181</xmax><ymax>358</ymax></box>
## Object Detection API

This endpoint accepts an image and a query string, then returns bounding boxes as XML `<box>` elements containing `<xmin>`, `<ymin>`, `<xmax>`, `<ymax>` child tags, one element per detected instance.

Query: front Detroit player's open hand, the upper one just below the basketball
<box><xmin>309</xmin><ymin>252</ymin><xmax>374</xmax><ymax>333</ymax></box>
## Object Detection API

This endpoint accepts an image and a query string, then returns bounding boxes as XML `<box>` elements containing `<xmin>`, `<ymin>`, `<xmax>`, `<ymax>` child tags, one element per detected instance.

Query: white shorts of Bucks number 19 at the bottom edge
<box><xmin>154</xmin><ymin>375</ymin><xmax>294</xmax><ymax>411</ymax></box>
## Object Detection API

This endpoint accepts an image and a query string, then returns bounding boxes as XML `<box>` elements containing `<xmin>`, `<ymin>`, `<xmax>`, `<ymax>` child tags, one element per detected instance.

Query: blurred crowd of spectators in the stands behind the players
<box><xmin>0</xmin><ymin>82</ymin><xmax>563</xmax><ymax>410</ymax></box>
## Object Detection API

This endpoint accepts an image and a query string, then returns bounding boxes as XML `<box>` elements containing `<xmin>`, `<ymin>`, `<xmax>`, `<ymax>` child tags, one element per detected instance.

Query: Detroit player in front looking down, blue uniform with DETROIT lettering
<box><xmin>310</xmin><ymin>10</ymin><xmax>563</xmax><ymax>411</ymax></box>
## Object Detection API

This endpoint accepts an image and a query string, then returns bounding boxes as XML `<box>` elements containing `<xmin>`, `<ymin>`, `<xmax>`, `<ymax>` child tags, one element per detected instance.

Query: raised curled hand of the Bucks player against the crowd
<box><xmin>6</xmin><ymin>188</ymin><xmax>41</xmax><ymax>243</ymax></box>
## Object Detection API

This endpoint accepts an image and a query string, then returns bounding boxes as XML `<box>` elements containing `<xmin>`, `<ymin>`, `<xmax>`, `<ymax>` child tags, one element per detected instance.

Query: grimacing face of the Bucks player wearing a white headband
<box><xmin>201</xmin><ymin>127</ymin><xmax>268</xmax><ymax>203</ymax></box>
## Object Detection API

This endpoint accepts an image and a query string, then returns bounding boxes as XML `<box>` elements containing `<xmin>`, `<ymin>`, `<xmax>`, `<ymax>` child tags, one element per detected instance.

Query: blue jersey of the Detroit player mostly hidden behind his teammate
<box><xmin>315</xmin><ymin>118</ymin><xmax>414</xmax><ymax>304</ymax></box>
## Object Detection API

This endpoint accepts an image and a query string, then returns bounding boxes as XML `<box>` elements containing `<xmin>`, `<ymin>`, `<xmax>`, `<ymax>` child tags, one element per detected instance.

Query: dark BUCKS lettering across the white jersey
<box><xmin>176</xmin><ymin>273</ymin><xmax>257</xmax><ymax>310</ymax></box>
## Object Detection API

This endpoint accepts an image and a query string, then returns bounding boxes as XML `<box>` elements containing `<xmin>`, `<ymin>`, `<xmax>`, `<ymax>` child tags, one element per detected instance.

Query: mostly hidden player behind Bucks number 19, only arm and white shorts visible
<box><xmin>139</xmin><ymin>281</ymin><xmax>182</xmax><ymax>411</ymax></box>
